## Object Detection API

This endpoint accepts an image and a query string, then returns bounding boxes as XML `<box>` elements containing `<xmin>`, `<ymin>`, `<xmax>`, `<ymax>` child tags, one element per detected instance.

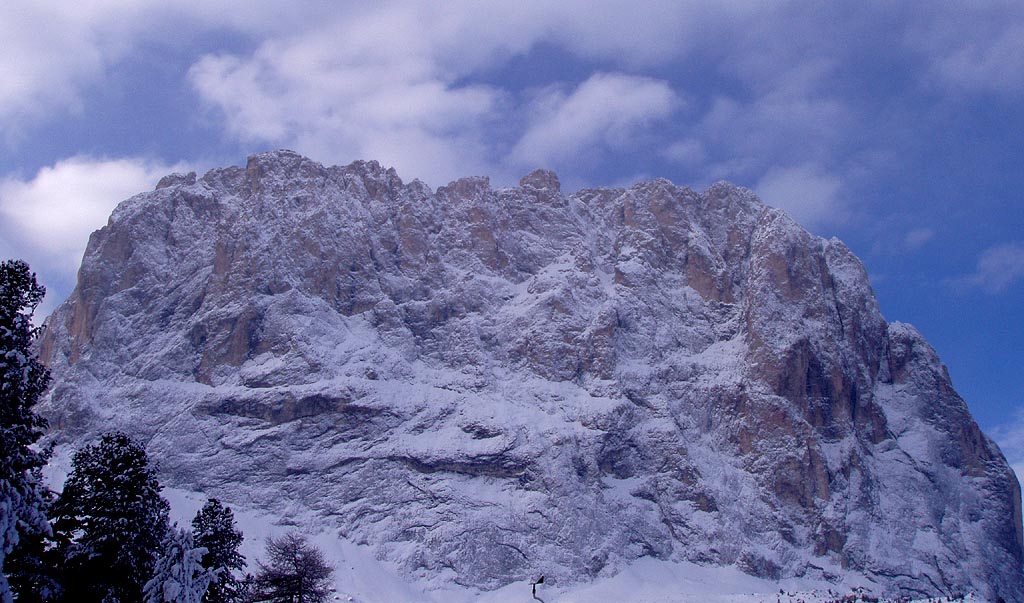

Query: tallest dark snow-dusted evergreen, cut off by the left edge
<box><xmin>0</xmin><ymin>260</ymin><xmax>50</xmax><ymax>603</ymax></box>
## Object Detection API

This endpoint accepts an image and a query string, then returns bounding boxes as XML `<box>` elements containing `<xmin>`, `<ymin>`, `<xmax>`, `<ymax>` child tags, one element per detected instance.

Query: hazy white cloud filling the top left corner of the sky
<box><xmin>0</xmin><ymin>0</ymin><xmax>331</xmax><ymax>138</ymax></box>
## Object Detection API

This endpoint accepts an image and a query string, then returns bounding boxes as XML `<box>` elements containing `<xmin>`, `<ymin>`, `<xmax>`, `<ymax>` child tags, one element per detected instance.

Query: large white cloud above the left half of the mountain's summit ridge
<box><xmin>189</xmin><ymin>9</ymin><xmax>502</xmax><ymax>184</ymax></box>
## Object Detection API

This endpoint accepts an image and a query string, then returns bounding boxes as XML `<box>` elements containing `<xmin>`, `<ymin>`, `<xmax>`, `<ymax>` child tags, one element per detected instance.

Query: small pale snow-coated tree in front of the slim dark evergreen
<box><xmin>145</xmin><ymin>524</ymin><xmax>215</xmax><ymax>603</ymax></box>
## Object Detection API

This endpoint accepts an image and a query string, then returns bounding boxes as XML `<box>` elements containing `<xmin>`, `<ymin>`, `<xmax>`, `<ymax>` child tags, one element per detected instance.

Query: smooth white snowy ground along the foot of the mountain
<box><xmin>45</xmin><ymin>446</ymin><xmax>990</xmax><ymax>603</ymax></box>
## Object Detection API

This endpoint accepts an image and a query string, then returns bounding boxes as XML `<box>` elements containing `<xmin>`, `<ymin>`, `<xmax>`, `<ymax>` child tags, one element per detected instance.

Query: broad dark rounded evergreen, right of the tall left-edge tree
<box><xmin>54</xmin><ymin>432</ymin><xmax>168</xmax><ymax>603</ymax></box>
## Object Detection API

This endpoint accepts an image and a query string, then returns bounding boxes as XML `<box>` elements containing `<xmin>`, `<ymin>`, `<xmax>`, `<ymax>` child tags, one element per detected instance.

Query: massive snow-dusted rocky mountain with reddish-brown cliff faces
<box><xmin>41</xmin><ymin>152</ymin><xmax>1024</xmax><ymax>600</ymax></box>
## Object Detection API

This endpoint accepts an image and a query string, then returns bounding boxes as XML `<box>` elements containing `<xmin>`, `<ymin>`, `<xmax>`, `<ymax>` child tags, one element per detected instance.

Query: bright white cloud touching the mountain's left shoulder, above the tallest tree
<box><xmin>0</xmin><ymin>157</ymin><xmax>182</xmax><ymax>311</ymax></box>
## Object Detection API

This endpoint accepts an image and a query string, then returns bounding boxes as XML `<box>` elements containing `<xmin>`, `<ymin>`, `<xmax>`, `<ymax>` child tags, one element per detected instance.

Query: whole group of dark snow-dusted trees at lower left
<box><xmin>0</xmin><ymin>260</ymin><xmax>333</xmax><ymax>603</ymax></box>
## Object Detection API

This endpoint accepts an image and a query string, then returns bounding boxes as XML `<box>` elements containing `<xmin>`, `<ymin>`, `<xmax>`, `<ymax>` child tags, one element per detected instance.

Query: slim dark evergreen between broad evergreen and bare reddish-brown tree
<box><xmin>193</xmin><ymin>499</ymin><xmax>246</xmax><ymax>603</ymax></box>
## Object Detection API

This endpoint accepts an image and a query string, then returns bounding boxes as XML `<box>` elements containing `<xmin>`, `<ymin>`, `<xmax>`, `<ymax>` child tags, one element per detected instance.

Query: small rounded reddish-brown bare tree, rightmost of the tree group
<box><xmin>252</xmin><ymin>532</ymin><xmax>334</xmax><ymax>603</ymax></box>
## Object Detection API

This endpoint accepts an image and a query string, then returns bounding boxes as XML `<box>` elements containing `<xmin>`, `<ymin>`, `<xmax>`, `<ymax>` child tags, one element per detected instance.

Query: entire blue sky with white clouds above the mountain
<box><xmin>0</xmin><ymin>0</ymin><xmax>1024</xmax><ymax>468</ymax></box>
